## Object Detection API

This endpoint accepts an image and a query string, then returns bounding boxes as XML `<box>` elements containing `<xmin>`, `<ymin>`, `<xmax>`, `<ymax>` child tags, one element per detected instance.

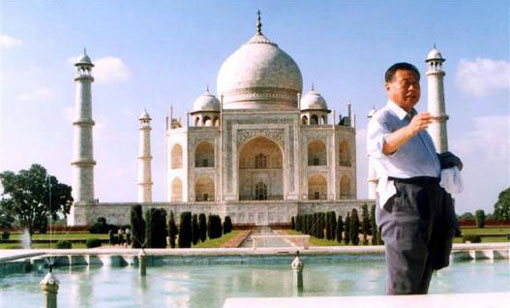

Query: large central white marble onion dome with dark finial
<box><xmin>217</xmin><ymin>17</ymin><xmax>303</xmax><ymax>110</ymax></box>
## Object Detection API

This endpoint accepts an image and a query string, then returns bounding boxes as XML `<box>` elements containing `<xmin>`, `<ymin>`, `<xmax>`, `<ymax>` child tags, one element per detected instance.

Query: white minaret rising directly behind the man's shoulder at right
<box><xmin>425</xmin><ymin>45</ymin><xmax>448</xmax><ymax>153</ymax></box>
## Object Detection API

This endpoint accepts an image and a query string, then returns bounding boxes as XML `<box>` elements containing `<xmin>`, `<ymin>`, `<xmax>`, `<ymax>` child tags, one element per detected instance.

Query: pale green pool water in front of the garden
<box><xmin>0</xmin><ymin>256</ymin><xmax>510</xmax><ymax>308</ymax></box>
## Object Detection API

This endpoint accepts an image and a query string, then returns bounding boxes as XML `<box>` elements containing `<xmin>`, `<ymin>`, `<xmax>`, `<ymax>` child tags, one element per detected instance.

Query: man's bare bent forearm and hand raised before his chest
<box><xmin>383</xmin><ymin>112</ymin><xmax>432</xmax><ymax>155</ymax></box>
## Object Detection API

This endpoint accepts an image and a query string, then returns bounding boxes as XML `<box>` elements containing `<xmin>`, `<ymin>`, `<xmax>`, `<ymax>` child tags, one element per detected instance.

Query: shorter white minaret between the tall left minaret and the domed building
<box><xmin>138</xmin><ymin>111</ymin><xmax>152</xmax><ymax>203</ymax></box>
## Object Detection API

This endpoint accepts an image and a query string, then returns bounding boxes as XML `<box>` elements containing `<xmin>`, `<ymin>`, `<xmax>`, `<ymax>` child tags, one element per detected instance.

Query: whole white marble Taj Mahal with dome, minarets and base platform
<box><xmin>68</xmin><ymin>15</ymin><xmax>447</xmax><ymax>226</ymax></box>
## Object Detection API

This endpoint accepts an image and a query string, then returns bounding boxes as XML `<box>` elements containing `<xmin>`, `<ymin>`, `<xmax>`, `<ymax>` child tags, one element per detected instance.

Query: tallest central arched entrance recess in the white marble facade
<box><xmin>239</xmin><ymin>137</ymin><xmax>283</xmax><ymax>200</ymax></box>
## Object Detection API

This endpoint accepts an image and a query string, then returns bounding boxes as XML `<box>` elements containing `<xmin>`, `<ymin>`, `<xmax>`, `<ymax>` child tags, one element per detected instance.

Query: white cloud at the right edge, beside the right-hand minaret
<box><xmin>456</xmin><ymin>58</ymin><xmax>510</xmax><ymax>96</ymax></box>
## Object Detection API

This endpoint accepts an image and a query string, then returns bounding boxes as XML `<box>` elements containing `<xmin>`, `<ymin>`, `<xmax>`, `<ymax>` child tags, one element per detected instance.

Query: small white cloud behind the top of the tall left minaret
<box><xmin>67</xmin><ymin>56</ymin><xmax>131</xmax><ymax>83</ymax></box>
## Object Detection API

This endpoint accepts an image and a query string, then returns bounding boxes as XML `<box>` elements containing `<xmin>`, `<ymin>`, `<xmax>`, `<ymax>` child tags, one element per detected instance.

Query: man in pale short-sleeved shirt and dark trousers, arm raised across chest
<box><xmin>367</xmin><ymin>63</ymin><xmax>462</xmax><ymax>294</ymax></box>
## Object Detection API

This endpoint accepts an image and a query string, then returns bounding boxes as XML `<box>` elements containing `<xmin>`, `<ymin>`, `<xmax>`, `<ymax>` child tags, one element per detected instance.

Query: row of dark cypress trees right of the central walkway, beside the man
<box><xmin>291</xmin><ymin>204</ymin><xmax>382</xmax><ymax>245</ymax></box>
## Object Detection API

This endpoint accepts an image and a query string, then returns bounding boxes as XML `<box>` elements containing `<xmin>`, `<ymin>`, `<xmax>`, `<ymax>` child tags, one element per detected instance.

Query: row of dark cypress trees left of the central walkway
<box><xmin>130</xmin><ymin>204</ymin><xmax>232</xmax><ymax>248</ymax></box>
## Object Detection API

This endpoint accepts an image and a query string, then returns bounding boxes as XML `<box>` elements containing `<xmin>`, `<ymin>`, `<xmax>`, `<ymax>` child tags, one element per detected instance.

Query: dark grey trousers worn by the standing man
<box><xmin>376</xmin><ymin>178</ymin><xmax>451</xmax><ymax>294</ymax></box>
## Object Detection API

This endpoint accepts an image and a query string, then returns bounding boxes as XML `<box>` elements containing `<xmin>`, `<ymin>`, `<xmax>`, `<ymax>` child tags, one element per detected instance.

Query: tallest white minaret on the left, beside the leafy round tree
<box><xmin>68</xmin><ymin>50</ymin><xmax>96</xmax><ymax>226</ymax></box>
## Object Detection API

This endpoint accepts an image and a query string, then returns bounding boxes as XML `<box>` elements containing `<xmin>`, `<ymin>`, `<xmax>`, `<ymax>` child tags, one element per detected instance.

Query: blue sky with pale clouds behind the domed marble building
<box><xmin>0</xmin><ymin>1</ymin><xmax>510</xmax><ymax>213</ymax></box>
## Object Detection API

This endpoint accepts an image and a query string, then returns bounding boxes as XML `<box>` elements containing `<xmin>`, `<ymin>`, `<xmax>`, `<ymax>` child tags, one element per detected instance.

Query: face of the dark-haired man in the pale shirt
<box><xmin>386</xmin><ymin>70</ymin><xmax>420</xmax><ymax>112</ymax></box>
